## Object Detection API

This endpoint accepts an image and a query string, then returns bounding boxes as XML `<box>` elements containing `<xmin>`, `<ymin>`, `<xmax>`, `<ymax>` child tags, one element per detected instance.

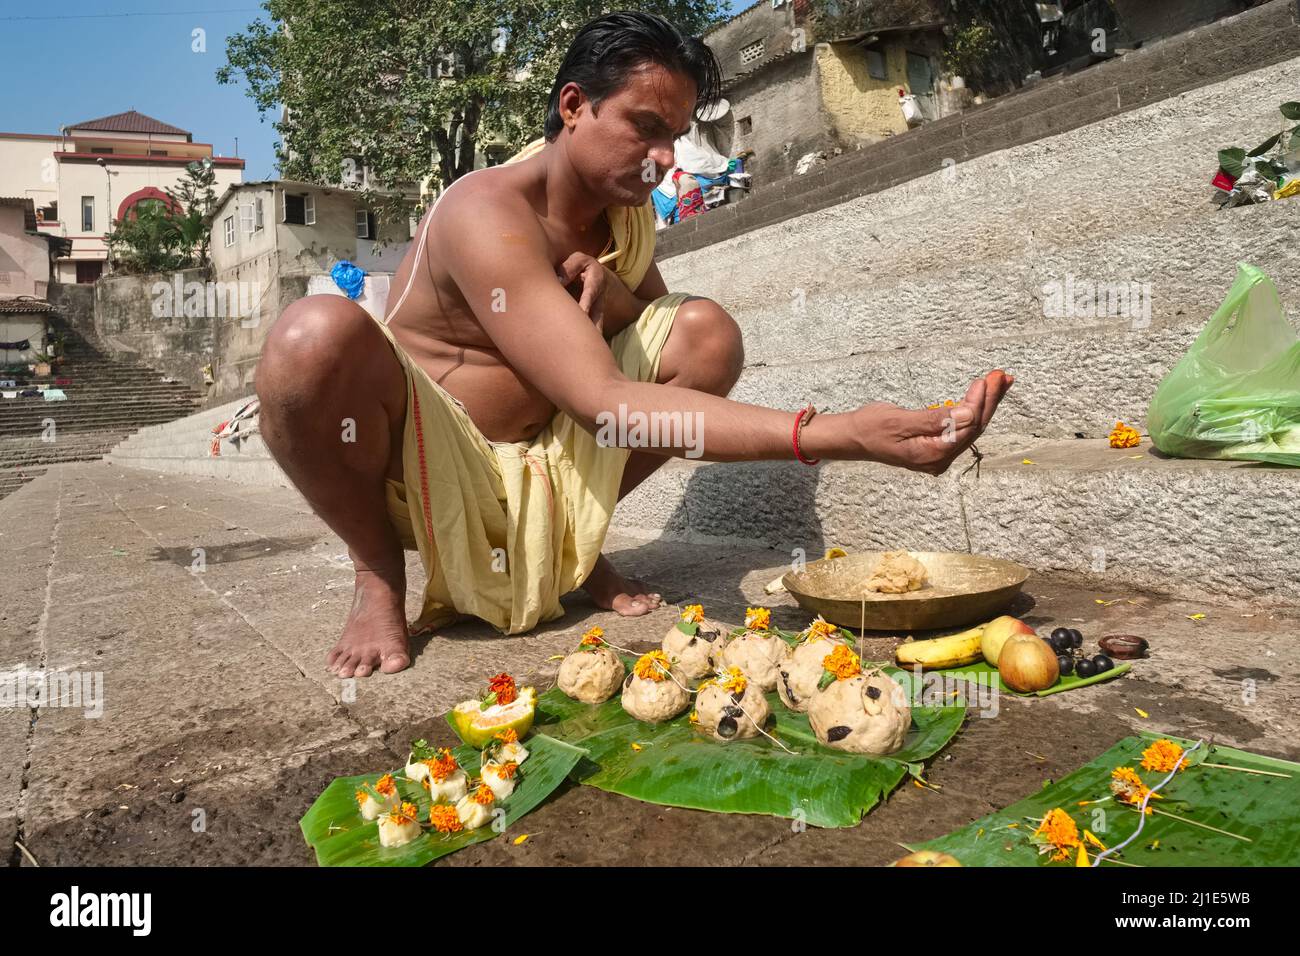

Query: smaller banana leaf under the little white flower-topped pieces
<box><xmin>298</xmin><ymin>734</ymin><xmax>584</xmax><ymax>866</ymax></box>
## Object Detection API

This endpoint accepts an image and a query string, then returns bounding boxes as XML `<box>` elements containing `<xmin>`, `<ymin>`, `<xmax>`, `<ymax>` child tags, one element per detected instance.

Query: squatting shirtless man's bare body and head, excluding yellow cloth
<box><xmin>248</xmin><ymin>13</ymin><xmax>1011</xmax><ymax>678</ymax></box>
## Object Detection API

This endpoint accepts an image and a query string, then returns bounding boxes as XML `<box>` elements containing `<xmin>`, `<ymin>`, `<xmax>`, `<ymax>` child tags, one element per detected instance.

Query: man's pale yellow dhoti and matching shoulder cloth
<box><xmin>378</xmin><ymin>144</ymin><xmax>688</xmax><ymax>633</ymax></box>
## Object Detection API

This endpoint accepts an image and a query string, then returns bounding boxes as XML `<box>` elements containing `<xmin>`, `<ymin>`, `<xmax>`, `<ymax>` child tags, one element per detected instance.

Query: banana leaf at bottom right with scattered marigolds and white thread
<box><xmin>909</xmin><ymin>734</ymin><xmax>1300</xmax><ymax>866</ymax></box>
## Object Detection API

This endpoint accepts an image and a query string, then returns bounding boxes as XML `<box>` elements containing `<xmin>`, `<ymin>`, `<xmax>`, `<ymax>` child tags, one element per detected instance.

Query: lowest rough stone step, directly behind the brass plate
<box><xmin>611</xmin><ymin>440</ymin><xmax>1300</xmax><ymax>606</ymax></box>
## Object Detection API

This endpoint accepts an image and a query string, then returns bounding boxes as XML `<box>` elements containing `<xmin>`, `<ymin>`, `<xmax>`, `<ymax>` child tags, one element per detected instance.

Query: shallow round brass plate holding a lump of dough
<box><xmin>781</xmin><ymin>551</ymin><xmax>1030</xmax><ymax>631</ymax></box>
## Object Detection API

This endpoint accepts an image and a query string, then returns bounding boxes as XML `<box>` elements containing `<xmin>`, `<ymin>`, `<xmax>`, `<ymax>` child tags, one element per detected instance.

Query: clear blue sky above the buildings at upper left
<box><xmin>0</xmin><ymin>0</ymin><xmax>750</xmax><ymax>179</ymax></box>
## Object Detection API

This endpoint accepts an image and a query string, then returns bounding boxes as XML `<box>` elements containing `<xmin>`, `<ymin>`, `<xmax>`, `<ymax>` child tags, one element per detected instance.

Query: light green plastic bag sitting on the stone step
<box><xmin>1147</xmin><ymin>263</ymin><xmax>1300</xmax><ymax>466</ymax></box>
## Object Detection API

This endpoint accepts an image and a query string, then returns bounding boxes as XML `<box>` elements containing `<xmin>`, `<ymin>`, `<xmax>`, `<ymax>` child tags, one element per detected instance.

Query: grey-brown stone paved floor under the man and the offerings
<box><xmin>0</xmin><ymin>462</ymin><xmax>1300</xmax><ymax>865</ymax></box>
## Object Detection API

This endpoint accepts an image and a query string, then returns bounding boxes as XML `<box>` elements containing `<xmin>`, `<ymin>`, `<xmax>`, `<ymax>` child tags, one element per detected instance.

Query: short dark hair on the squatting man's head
<box><xmin>545</xmin><ymin>10</ymin><xmax>722</xmax><ymax>142</ymax></box>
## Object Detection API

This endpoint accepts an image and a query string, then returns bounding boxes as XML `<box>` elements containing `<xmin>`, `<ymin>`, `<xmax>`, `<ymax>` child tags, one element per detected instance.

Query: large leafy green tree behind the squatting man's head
<box><xmin>217</xmin><ymin>0</ymin><xmax>723</xmax><ymax>216</ymax></box>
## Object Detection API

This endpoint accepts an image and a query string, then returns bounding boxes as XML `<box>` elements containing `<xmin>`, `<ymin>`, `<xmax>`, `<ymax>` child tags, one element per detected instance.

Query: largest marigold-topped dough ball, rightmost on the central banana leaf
<box><xmin>809</xmin><ymin>646</ymin><xmax>911</xmax><ymax>754</ymax></box>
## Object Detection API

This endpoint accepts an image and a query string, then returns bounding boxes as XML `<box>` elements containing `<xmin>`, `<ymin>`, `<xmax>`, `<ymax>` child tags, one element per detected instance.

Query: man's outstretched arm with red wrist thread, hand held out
<box><xmin>429</xmin><ymin>181</ymin><xmax>1011</xmax><ymax>473</ymax></box>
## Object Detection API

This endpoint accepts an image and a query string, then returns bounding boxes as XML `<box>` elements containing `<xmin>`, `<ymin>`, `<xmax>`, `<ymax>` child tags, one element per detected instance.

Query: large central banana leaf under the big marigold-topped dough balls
<box><xmin>537</xmin><ymin>669</ymin><xmax>966</xmax><ymax>827</ymax></box>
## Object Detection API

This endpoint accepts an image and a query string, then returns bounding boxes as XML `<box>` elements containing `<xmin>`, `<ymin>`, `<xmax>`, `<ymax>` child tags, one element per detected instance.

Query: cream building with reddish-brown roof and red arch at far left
<box><xmin>0</xmin><ymin>111</ymin><xmax>244</xmax><ymax>282</ymax></box>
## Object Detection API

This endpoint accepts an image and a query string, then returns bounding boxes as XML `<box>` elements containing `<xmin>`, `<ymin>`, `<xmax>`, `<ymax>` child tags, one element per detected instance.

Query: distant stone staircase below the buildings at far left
<box><xmin>0</xmin><ymin>319</ymin><xmax>202</xmax><ymax>498</ymax></box>
